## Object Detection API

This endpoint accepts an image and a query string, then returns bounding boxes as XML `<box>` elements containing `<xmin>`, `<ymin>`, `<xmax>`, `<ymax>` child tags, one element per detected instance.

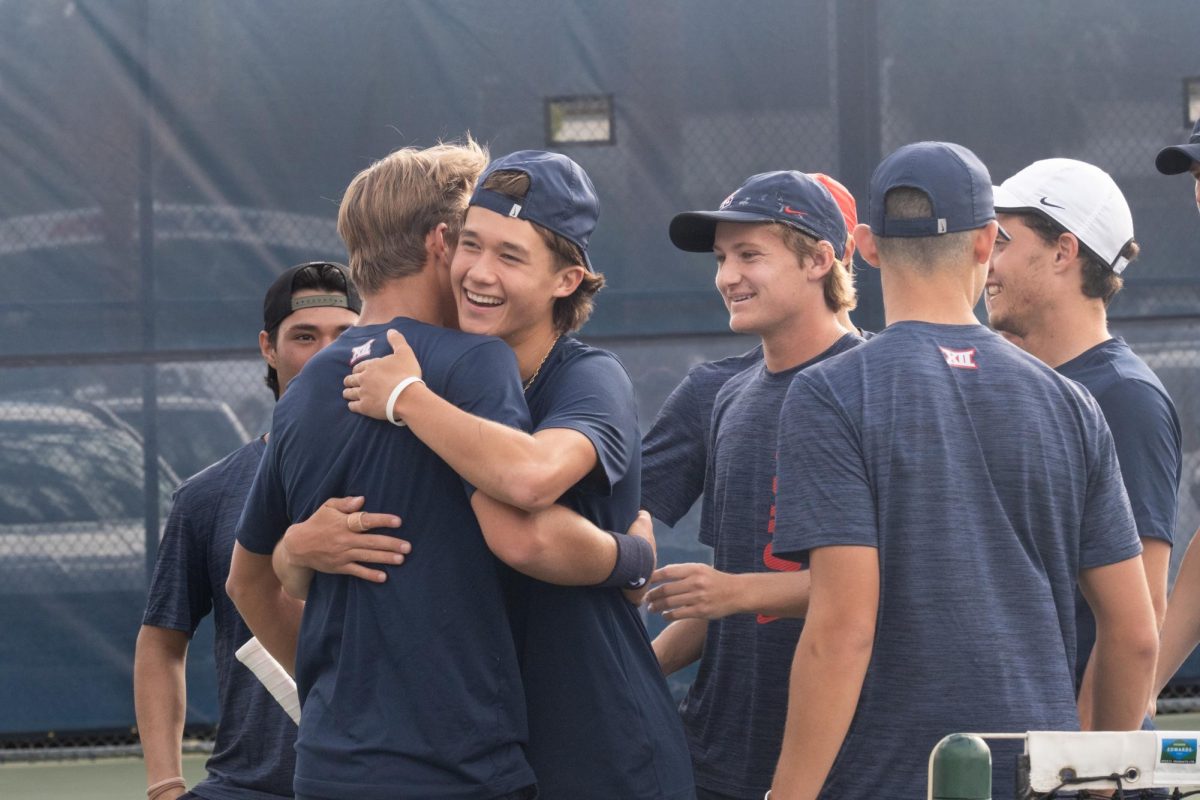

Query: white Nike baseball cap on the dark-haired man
<box><xmin>992</xmin><ymin>158</ymin><xmax>1133</xmax><ymax>275</ymax></box>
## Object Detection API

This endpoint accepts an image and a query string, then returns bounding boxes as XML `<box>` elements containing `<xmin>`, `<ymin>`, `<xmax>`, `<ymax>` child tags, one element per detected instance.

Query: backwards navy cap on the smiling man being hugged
<box><xmin>468</xmin><ymin>150</ymin><xmax>600</xmax><ymax>271</ymax></box>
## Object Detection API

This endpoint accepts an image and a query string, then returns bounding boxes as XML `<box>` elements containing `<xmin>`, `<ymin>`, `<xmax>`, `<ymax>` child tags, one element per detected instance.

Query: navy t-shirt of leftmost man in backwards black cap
<box><xmin>142</xmin><ymin>438</ymin><xmax>296</xmax><ymax>800</ymax></box>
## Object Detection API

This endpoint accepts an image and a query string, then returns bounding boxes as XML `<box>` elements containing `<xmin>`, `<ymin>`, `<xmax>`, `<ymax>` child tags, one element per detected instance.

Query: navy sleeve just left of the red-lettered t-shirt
<box><xmin>642</xmin><ymin>344</ymin><xmax>762</xmax><ymax>527</ymax></box>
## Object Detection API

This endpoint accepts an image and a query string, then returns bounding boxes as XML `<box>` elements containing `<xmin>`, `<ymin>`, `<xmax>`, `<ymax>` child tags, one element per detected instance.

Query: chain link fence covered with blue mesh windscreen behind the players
<box><xmin>0</xmin><ymin>0</ymin><xmax>1200</xmax><ymax>760</ymax></box>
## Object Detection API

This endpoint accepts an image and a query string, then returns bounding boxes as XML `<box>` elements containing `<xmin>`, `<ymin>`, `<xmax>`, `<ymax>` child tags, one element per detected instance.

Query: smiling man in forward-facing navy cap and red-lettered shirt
<box><xmin>643</xmin><ymin>170</ymin><xmax>860</xmax><ymax>800</ymax></box>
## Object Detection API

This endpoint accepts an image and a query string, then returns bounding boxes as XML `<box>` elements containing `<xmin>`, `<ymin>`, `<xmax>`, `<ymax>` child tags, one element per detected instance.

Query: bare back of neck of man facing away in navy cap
<box><xmin>880</xmin><ymin>265</ymin><xmax>984</xmax><ymax>325</ymax></box>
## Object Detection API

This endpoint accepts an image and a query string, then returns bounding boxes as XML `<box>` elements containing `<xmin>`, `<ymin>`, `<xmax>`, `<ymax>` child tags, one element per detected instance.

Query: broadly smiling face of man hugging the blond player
<box><xmin>450</xmin><ymin>206</ymin><xmax>582</xmax><ymax>347</ymax></box>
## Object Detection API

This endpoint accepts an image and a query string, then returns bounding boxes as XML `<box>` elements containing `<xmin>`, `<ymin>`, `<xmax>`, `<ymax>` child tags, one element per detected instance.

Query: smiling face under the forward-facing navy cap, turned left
<box><xmin>713</xmin><ymin>222</ymin><xmax>824</xmax><ymax>337</ymax></box>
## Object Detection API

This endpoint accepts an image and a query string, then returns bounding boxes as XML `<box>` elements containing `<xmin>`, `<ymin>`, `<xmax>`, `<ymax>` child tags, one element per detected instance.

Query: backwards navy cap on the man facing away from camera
<box><xmin>868</xmin><ymin>142</ymin><xmax>996</xmax><ymax>237</ymax></box>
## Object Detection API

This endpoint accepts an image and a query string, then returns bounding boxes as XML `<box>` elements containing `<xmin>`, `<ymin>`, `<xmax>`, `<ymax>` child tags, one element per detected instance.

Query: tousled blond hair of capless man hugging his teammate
<box><xmin>337</xmin><ymin>134</ymin><xmax>487</xmax><ymax>293</ymax></box>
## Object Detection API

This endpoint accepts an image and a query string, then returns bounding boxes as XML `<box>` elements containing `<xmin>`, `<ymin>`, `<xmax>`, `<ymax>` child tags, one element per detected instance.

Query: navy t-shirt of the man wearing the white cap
<box><xmin>1057</xmin><ymin>338</ymin><xmax>1183</xmax><ymax>685</ymax></box>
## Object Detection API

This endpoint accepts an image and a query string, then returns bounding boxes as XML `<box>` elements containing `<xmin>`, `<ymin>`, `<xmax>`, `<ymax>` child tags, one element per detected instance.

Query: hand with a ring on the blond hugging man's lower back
<box><xmin>283</xmin><ymin>498</ymin><xmax>413</xmax><ymax>583</ymax></box>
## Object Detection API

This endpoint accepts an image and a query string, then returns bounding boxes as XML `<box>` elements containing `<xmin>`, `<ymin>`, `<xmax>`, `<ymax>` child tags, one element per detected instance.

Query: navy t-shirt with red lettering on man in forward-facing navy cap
<box><xmin>680</xmin><ymin>333</ymin><xmax>860</xmax><ymax>800</ymax></box>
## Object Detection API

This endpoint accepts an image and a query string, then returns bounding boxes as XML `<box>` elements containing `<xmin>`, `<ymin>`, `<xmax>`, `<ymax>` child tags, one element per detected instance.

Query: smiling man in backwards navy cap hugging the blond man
<box><xmin>346</xmin><ymin>150</ymin><xmax>695</xmax><ymax>800</ymax></box>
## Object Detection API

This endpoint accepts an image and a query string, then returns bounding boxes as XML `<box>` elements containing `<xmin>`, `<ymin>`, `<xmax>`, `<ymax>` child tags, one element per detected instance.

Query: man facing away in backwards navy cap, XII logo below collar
<box><xmin>770</xmin><ymin>142</ymin><xmax>1158</xmax><ymax>800</ymax></box>
